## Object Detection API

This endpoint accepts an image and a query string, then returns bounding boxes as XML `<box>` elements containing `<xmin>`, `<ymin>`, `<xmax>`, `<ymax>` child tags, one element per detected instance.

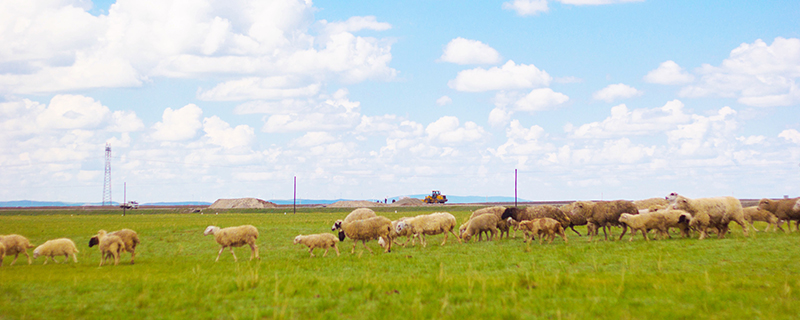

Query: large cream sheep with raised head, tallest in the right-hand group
<box><xmin>666</xmin><ymin>192</ymin><xmax>749</xmax><ymax>239</ymax></box>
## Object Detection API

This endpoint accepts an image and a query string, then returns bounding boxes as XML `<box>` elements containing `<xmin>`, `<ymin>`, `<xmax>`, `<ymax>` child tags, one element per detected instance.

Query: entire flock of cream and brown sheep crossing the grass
<box><xmin>0</xmin><ymin>193</ymin><xmax>800</xmax><ymax>266</ymax></box>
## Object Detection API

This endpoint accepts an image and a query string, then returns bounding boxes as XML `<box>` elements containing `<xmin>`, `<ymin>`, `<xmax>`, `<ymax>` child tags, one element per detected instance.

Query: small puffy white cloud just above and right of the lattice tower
<box><xmin>150</xmin><ymin>104</ymin><xmax>203</xmax><ymax>141</ymax></box>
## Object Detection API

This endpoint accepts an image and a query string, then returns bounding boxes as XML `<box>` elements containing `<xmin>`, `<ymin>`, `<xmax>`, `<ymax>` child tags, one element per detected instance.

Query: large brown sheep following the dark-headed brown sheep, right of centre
<box><xmin>572</xmin><ymin>200</ymin><xmax>639</xmax><ymax>241</ymax></box>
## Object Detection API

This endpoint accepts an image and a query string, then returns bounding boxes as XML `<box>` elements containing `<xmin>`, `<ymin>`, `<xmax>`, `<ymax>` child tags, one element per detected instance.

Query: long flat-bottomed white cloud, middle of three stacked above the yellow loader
<box><xmin>447</xmin><ymin>60</ymin><xmax>553</xmax><ymax>92</ymax></box>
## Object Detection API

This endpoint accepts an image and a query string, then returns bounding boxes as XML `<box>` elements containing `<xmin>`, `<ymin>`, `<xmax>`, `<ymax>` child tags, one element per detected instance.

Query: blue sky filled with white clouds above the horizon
<box><xmin>0</xmin><ymin>0</ymin><xmax>800</xmax><ymax>203</ymax></box>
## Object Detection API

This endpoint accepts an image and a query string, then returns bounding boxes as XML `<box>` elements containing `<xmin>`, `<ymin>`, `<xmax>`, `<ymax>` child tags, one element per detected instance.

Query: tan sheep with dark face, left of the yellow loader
<box><xmin>333</xmin><ymin>216</ymin><xmax>393</xmax><ymax>254</ymax></box>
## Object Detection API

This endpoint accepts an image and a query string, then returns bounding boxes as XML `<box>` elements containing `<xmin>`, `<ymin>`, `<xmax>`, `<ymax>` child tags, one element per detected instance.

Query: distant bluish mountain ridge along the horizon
<box><xmin>0</xmin><ymin>194</ymin><xmax>528</xmax><ymax>208</ymax></box>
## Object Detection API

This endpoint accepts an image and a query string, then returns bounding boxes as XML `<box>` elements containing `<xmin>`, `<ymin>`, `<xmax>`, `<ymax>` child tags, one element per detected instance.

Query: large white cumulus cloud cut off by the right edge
<box><xmin>680</xmin><ymin>37</ymin><xmax>800</xmax><ymax>107</ymax></box>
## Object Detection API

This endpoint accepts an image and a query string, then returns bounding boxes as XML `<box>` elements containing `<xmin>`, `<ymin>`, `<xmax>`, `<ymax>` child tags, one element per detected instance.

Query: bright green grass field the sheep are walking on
<box><xmin>0</xmin><ymin>207</ymin><xmax>800</xmax><ymax>319</ymax></box>
